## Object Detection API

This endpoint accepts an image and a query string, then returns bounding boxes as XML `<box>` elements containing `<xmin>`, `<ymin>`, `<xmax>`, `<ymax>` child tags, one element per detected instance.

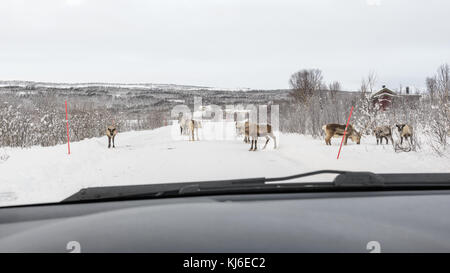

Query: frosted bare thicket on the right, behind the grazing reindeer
<box><xmin>280</xmin><ymin>65</ymin><xmax>450</xmax><ymax>155</ymax></box>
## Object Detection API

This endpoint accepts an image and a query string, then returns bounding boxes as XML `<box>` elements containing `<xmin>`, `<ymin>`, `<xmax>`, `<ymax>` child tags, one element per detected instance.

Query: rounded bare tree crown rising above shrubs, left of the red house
<box><xmin>289</xmin><ymin>69</ymin><xmax>324</xmax><ymax>103</ymax></box>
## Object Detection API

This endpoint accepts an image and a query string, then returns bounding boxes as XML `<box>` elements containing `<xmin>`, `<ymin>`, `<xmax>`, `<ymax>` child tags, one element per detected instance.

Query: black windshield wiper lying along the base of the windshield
<box><xmin>61</xmin><ymin>170</ymin><xmax>450</xmax><ymax>203</ymax></box>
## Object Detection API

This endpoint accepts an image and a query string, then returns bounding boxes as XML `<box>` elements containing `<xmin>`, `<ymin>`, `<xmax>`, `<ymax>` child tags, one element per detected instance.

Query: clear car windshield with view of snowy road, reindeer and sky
<box><xmin>0</xmin><ymin>0</ymin><xmax>450</xmax><ymax>207</ymax></box>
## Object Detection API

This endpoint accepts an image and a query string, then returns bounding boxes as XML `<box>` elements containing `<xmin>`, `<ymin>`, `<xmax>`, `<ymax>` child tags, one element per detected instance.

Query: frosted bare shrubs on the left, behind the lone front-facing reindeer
<box><xmin>0</xmin><ymin>94</ymin><xmax>166</xmax><ymax>147</ymax></box>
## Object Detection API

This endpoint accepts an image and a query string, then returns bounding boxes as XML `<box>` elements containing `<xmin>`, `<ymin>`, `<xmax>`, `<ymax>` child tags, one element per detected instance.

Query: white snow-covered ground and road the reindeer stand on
<box><xmin>0</xmin><ymin>126</ymin><xmax>450</xmax><ymax>206</ymax></box>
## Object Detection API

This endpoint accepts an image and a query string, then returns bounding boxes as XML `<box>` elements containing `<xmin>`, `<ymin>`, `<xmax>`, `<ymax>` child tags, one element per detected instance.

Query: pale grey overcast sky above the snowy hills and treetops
<box><xmin>0</xmin><ymin>0</ymin><xmax>450</xmax><ymax>90</ymax></box>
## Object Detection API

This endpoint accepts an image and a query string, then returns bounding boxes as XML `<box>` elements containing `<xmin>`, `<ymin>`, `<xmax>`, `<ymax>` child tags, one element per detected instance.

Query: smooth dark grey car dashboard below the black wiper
<box><xmin>0</xmin><ymin>190</ymin><xmax>450</xmax><ymax>253</ymax></box>
